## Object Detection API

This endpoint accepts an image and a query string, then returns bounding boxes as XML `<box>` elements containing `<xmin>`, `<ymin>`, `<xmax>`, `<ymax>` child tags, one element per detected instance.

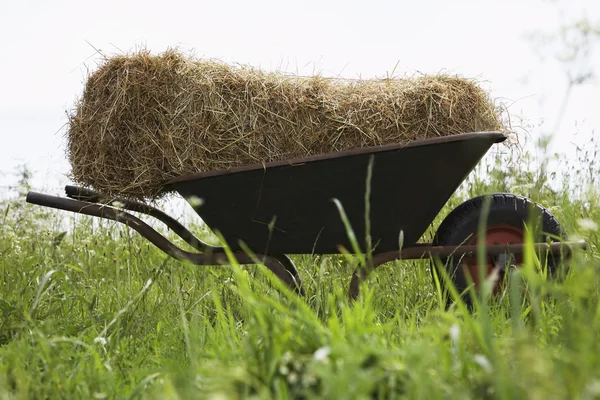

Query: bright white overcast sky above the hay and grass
<box><xmin>0</xmin><ymin>0</ymin><xmax>600</xmax><ymax>197</ymax></box>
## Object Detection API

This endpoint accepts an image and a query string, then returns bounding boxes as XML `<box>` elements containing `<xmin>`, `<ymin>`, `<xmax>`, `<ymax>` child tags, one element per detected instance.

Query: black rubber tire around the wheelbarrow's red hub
<box><xmin>431</xmin><ymin>193</ymin><xmax>565</xmax><ymax>306</ymax></box>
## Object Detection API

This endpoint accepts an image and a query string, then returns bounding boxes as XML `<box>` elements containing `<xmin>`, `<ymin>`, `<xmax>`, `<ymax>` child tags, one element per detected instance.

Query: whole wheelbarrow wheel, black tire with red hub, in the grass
<box><xmin>432</xmin><ymin>193</ymin><xmax>565</xmax><ymax>307</ymax></box>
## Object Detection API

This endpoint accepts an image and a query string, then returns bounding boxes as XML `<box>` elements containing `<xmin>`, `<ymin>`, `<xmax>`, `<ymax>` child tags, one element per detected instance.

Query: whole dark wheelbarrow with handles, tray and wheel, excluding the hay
<box><xmin>26</xmin><ymin>132</ymin><xmax>586</xmax><ymax>299</ymax></box>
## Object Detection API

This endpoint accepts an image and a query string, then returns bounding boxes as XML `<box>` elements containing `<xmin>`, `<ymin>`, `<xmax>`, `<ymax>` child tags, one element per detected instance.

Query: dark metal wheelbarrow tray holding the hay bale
<box><xmin>167</xmin><ymin>132</ymin><xmax>505</xmax><ymax>254</ymax></box>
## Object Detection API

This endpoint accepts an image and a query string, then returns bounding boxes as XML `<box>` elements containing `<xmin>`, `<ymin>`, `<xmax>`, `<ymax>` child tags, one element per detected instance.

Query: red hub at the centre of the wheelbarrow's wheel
<box><xmin>463</xmin><ymin>224</ymin><xmax>523</xmax><ymax>294</ymax></box>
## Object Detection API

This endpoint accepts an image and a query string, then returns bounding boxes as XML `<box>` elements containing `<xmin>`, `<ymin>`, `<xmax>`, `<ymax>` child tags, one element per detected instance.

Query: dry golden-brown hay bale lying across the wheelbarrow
<box><xmin>68</xmin><ymin>50</ymin><xmax>503</xmax><ymax>199</ymax></box>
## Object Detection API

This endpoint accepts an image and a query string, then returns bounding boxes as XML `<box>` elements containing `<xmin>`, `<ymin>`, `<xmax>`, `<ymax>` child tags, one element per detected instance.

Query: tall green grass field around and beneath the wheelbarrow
<box><xmin>0</xmin><ymin>139</ymin><xmax>600</xmax><ymax>399</ymax></box>
